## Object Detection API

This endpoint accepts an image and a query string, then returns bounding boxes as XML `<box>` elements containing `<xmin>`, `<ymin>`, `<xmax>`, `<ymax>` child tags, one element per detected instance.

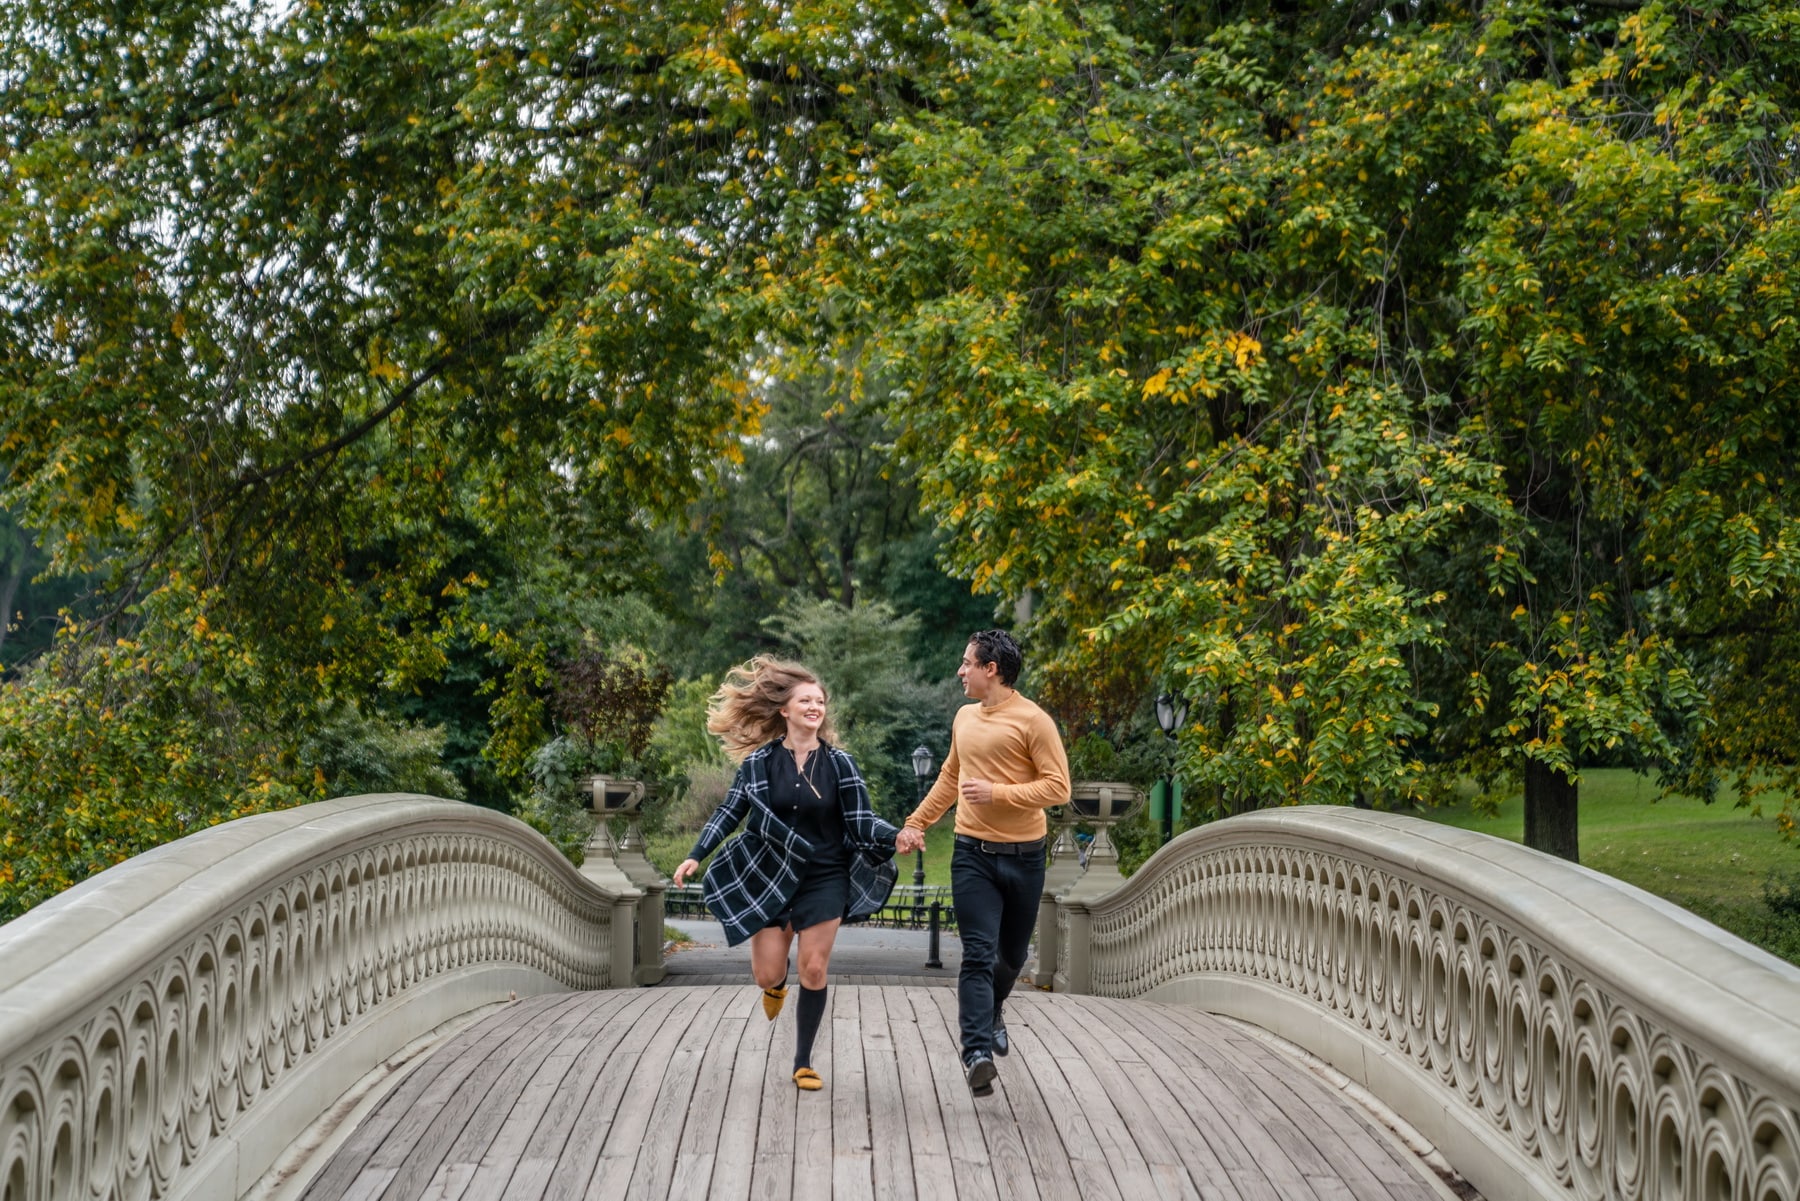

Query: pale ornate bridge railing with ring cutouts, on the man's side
<box><xmin>1058</xmin><ymin>808</ymin><xmax>1800</xmax><ymax>1201</ymax></box>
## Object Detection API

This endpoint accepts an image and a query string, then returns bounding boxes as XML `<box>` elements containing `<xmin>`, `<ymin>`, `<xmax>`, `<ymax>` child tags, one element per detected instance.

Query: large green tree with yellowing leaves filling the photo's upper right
<box><xmin>859</xmin><ymin>4</ymin><xmax>1800</xmax><ymax>853</ymax></box>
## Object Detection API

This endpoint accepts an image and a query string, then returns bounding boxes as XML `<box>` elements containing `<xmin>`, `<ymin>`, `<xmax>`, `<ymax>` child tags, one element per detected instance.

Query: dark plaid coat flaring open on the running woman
<box><xmin>689</xmin><ymin>742</ymin><xmax>900</xmax><ymax>947</ymax></box>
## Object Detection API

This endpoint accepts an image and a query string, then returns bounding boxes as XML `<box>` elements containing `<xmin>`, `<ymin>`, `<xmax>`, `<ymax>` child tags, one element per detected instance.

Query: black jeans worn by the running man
<box><xmin>950</xmin><ymin>839</ymin><xmax>1044</xmax><ymax>1059</ymax></box>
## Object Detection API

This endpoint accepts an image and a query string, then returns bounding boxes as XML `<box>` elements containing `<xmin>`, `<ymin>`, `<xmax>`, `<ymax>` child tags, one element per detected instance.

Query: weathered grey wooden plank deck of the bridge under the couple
<box><xmin>304</xmin><ymin>983</ymin><xmax>1449</xmax><ymax>1201</ymax></box>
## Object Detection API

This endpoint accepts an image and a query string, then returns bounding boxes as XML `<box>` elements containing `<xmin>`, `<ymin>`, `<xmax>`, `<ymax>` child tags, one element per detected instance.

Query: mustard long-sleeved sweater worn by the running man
<box><xmin>905</xmin><ymin>693</ymin><xmax>1069</xmax><ymax>843</ymax></box>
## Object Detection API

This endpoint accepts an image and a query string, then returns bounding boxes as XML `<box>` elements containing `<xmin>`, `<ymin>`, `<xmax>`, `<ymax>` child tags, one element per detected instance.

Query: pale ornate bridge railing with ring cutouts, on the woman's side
<box><xmin>0</xmin><ymin>796</ymin><xmax>634</xmax><ymax>1201</ymax></box>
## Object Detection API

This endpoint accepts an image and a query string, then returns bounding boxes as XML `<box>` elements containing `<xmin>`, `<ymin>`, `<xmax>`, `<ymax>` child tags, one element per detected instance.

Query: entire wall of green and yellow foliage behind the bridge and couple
<box><xmin>0</xmin><ymin>0</ymin><xmax>1800</xmax><ymax>921</ymax></box>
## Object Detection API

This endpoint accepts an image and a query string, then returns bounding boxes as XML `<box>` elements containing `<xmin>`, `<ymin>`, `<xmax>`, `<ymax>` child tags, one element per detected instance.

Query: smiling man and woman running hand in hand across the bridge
<box><xmin>675</xmin><ymin>630</ymin><xmax>1069</xmax><ymax>1097</ymax></box>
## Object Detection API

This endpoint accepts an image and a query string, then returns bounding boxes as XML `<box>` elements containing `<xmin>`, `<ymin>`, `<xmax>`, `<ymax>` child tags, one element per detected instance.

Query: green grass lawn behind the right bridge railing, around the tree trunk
<box><xmin>1418</xmin><ymin>769</ymin><xmax>1800</xmax><ymax>963</ymax></box>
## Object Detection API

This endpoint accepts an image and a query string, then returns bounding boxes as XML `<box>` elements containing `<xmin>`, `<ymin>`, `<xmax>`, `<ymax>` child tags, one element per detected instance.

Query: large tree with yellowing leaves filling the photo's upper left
<box><xmin>0</xmin><ymin>0</ymin><xmax>812</xmax><ymax>897</ymax></box>
